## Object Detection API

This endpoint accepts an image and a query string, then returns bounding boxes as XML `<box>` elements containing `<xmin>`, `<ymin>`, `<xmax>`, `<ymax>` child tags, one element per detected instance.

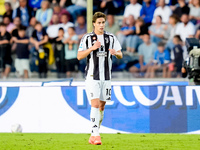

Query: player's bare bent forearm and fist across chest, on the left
<box><xmin>77</xmin><ymin>40</ymin><xmax>101</xmax><ymax>60</ymax></box>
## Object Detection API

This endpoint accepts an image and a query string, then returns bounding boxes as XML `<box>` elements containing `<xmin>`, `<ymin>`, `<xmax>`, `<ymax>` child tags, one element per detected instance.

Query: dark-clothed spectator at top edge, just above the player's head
<box><xmin>100</xmin><ymin>0</ymin><xmax>117</xmax><ymax>15</ymax></box>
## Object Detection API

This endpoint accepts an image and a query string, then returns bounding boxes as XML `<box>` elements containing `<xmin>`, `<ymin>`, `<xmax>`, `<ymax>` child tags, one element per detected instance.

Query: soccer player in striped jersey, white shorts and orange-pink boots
<box><xmin>77</xmin><ymin>12</ymin><xmax>123</xmax><ymax>145</ymax></box>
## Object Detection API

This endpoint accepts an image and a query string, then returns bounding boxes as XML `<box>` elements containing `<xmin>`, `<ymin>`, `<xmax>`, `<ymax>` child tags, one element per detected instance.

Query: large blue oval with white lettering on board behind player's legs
<box><xmin>61</xmin><ymin>82</ymin><xmax>200</xmax><ymax>133</ymax></box>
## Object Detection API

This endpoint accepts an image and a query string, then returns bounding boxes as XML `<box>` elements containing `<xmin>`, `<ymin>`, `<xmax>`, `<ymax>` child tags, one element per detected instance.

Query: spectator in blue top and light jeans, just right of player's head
<box><xmin>117</xmin><ymin>15</ymin><xmax>135</xmax><ymax>52</ymax></box>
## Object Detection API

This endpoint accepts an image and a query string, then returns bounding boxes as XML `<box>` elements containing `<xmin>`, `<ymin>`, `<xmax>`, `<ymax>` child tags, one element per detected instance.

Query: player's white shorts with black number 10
<box><xmin>85</xmin><ymin>79</ymin><xmax>111</xmax><ymax>101</ymax></box>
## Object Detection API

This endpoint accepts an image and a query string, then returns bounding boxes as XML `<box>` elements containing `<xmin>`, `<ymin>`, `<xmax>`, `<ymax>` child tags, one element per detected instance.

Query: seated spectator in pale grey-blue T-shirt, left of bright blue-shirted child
<box><xmin>129</xmin><ymin>34</ymin><xmax>157</xmax><ymax>74</ymax></box>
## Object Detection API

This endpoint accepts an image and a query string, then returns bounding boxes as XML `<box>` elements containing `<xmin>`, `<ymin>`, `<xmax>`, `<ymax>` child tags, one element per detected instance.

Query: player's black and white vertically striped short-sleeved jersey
<box><xmin>78</xmin><ymin>31</ymin><xmax>121</xmax><ymax>80</ymax></box>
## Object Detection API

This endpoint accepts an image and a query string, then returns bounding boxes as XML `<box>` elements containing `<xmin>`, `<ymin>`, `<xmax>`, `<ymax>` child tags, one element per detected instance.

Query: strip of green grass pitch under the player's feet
<box><xmin>0</xmin><ymin>133</ymin><xmax>200</xmax><ymax>150</ymax></box>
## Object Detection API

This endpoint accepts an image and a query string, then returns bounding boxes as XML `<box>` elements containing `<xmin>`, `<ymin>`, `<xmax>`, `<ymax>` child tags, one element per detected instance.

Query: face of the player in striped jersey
<box><xmin>93</xmin><ymin>18</ymin><xmax>106</xmax><ymax>34</ymax></box>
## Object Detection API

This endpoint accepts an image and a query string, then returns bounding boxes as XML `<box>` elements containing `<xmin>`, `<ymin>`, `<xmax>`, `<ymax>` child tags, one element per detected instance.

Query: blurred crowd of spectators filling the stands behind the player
<box><xmin>0</xmin><ymin>0</ymin><xmax>200</xmax><ymax>78</ymax></box>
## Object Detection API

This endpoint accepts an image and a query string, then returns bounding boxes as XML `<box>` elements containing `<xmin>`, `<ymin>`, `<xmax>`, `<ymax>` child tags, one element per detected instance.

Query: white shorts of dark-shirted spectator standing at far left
<box><xmin>15</xmin><ymin>58</ymin><xmax>30</xmax><ymax>76</ymax></box>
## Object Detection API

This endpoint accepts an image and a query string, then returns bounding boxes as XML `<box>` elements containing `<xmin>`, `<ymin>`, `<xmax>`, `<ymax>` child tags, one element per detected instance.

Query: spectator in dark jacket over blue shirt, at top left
<box><xmin>12</xmin><ymin>0</ymin><xmax>33</xmax><ymax>27</ymax></box>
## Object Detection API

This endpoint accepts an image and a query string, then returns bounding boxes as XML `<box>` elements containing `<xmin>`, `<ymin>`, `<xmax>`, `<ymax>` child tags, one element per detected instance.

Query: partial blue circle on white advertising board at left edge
<box><xmin>0</xmin><ymin>87</ymin><xmax>19</xmax><ymax>116</ymax></box>
